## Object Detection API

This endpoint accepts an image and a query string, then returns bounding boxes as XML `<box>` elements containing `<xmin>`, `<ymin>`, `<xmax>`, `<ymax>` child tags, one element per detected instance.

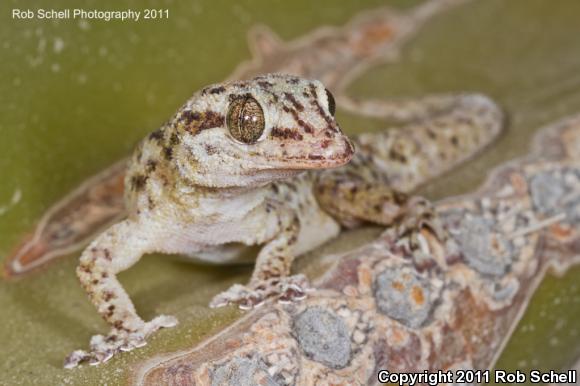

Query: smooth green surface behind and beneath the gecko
<box><xmin>0</xmin><ymin>0</ymin><xmax>580</xmax><ymax>385</ymax></box>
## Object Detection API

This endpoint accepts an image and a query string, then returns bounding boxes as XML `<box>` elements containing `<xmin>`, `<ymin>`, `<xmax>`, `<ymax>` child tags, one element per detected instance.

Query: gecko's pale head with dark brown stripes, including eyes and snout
<box><xmin>171</xmin><ymin>74</ymin><xmax>354</xmax><ymax>187</ymax></box>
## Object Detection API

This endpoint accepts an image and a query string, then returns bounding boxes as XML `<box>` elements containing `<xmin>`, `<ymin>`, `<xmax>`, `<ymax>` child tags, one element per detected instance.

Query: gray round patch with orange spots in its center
<box><xmin>373</xmin><ymin>267</ymin><xmax>433</xmax><ymax>328</ymax></box>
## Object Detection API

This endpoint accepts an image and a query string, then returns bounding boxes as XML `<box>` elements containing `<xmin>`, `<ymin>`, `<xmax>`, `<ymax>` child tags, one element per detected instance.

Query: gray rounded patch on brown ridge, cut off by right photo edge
<box><xmin>530</xmin><ymin>168</ymin><xmax>580</xmax><ymax>222</ymax></box>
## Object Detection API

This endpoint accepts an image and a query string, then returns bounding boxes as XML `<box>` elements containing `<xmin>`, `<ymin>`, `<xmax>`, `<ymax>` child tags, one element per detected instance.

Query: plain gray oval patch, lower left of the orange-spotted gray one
<box><xmin>293</xmin><ymin>307</ymin><xmax>351</xmax><ymax>369</ymax></box>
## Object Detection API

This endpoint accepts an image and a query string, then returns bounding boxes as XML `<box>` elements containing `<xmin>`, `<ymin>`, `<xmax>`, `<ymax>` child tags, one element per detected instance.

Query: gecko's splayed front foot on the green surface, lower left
<box><xmin>64</xmin><ymin>315</ymin><xmax>177</xmax><ymax>369</ymax></box>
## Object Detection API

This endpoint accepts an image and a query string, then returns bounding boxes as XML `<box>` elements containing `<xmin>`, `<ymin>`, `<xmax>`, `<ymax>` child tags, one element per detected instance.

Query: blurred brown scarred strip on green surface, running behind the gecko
<box><xmin>3</xmin><ymin>0</ymin><xmax>467</xmax><ymax>278</ymax></box>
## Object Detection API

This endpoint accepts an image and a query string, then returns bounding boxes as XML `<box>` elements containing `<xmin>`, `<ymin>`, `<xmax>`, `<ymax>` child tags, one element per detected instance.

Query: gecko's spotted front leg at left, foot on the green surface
<box><xmin>65</xmin><ymin>220</ymin><xmax>177</xmax><ymax>368</ymax></box>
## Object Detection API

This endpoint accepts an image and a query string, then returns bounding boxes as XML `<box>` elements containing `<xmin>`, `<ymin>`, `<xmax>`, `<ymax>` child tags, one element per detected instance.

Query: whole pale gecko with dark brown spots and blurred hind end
<box><xmin>65</xmin><ymin>74</ymin><xmax>503</xmax><ymax>368</ymax></box>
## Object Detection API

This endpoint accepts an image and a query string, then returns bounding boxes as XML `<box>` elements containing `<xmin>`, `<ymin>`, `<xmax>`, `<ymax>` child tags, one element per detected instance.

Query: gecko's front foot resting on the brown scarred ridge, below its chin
<box><xmin>209</xmin><ymin>274</ymin><xmax>311</xmax><ymax>310</ymax></box>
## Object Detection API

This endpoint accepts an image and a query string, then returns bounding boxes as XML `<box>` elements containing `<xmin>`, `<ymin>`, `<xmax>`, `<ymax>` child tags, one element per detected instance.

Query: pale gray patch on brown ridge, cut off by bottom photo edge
<box><xmin>211</xmin><ymin>356</ymin><xmax>280</xmax><ymax>386</ymax></box>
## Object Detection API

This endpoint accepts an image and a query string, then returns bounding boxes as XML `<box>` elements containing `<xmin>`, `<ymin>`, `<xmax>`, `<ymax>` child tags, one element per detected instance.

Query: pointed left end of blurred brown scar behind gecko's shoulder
<box><xmin>3</xmin><ymin>159</ymin><xmax>127</xmax><ymax>278</ymax></box>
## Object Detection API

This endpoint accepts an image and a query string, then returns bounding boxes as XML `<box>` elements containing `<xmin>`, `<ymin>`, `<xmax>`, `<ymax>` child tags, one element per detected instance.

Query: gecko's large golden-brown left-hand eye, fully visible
<box><xmin>226</xmin><ymin>96</ymin><xmax>265</xmax><ymax>144</ymax></box>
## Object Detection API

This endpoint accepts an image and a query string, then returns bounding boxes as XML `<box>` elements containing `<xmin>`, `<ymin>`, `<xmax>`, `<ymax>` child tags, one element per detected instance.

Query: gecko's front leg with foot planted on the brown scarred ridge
<box><xmin>210</xmin><ymin>211</ymin><xmax>308</xmax><ymax>310</ymax></box>
